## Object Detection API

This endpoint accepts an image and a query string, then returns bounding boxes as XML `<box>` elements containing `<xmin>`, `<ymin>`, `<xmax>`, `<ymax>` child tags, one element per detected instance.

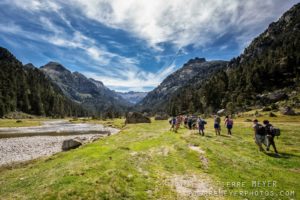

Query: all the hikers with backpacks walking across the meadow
<box><xmin>169</xmin><ymin>115</ymin><xmax>280</xmax><ymax>154</ymax></box>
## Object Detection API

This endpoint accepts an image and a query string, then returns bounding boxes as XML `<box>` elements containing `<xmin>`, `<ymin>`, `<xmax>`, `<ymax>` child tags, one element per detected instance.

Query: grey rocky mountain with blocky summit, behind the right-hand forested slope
<box><xmin>137</xmin><ymin>58</ymin><xmax>227</xmax><ymax>112</ymax></box>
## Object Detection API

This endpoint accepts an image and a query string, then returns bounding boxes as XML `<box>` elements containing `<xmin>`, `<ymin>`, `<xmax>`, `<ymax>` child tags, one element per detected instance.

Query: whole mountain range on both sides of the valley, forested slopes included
<box><xmin>0</xmin><ymin>4</ymin><xmax>300</xmax><ymax>117</ymax></box>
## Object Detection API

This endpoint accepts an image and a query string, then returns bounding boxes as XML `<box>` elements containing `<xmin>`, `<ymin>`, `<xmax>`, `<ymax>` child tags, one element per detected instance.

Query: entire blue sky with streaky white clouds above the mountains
<box><xmin>0</xmin><ymin>0</ymin><xmax>299</xmax><ymax>91</ymax></box>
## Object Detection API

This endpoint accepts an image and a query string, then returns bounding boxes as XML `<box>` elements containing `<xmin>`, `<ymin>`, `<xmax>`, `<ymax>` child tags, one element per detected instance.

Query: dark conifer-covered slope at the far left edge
<box><xmin>0</xmin><ymin>47</ymin><xmax>86</xmax><ymax>117</ymax></box>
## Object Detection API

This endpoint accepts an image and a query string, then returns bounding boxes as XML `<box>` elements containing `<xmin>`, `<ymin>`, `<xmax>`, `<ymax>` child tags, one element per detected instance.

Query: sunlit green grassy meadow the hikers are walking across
<box><xmin>0</xmin><ymin>113</ymin><xmax>300</xmax><ymax>199</ymax></box>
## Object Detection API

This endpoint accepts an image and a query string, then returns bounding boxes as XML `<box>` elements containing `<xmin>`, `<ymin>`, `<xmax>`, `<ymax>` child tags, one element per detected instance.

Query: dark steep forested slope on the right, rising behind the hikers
<box><xmin>167</xmin><ymin>4</ymin><xmax>300</xmax><ymax>113</ymax></box>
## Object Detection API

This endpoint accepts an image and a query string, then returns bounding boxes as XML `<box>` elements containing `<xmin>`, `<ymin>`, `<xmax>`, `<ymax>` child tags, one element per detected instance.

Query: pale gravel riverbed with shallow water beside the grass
<box><xmin>0</xmin><ymin>121</ymin><xmax>119</xmax><ymax>166</ymax></box>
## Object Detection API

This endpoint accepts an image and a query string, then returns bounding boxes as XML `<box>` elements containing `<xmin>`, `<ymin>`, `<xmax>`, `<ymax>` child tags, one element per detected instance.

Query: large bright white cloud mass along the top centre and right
<box><xmin>69</xmin><ymin>0</ymin><xmax>297</xmax><ymax>48</ymax></box>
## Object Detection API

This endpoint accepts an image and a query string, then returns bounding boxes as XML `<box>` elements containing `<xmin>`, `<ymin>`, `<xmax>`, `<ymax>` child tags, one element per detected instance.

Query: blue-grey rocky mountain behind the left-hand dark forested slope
<box><xmin>40</xmin><ymin>62</ymin><xmax>130</xmax><ymax>114</ymax></box>
